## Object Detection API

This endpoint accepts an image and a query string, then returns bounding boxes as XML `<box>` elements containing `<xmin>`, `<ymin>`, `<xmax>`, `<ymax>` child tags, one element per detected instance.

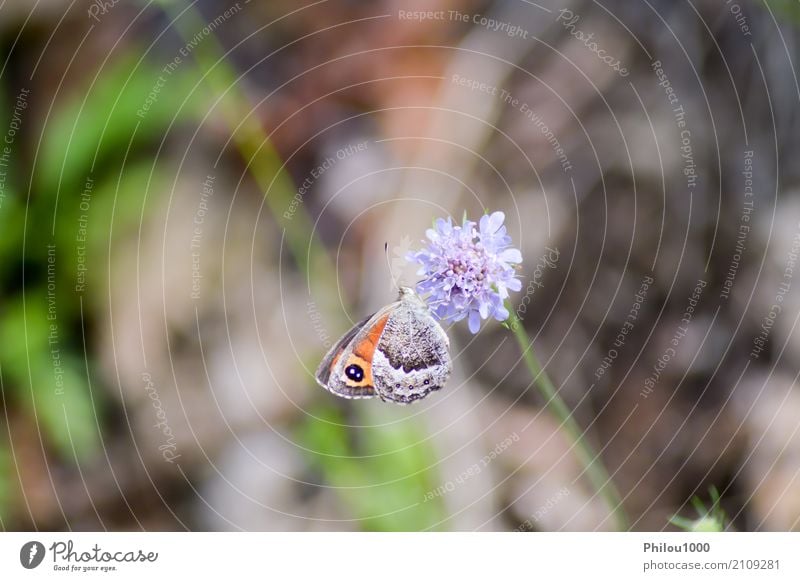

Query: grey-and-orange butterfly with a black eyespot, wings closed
<box><xmin>316</xmin><ymin>287</ymin><xmax>453</xmax><ymax>404</ymax></box>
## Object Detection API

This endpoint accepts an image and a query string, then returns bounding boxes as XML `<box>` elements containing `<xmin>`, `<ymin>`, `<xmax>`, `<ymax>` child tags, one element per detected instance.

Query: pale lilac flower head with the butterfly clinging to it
<box><xmin>406</xmin><ymin>212</ymin><xmax>522</xmax><ymax>333</ymax></box>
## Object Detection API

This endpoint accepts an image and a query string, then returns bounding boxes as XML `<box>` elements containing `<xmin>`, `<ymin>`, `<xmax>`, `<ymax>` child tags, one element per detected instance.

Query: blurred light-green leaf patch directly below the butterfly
<box><xmin>300</xmin><ymin>406</ymin><xmax>445</xmax><ymax>531</ymax></box>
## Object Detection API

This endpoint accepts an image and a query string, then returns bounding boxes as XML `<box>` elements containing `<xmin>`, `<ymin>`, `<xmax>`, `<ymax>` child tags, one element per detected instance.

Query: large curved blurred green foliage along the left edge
<box><xmin>0</xmin><ymin>46</ymin><xmax>190</xmax><ymax>472</ymax></box>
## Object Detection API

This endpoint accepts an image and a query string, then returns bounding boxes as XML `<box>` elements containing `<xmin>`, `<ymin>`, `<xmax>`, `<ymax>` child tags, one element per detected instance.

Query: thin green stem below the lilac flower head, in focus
<box><xmin>506</xmin><ymin>304</ymin><xmax>628</xmax><ymax>531</ymax></box>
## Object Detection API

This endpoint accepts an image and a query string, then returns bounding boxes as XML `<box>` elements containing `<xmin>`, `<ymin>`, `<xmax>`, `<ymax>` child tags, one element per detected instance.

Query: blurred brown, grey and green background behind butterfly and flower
<box><xmin>0</xmin><ymin>0</ymin><xmax>800</xmax><ymax>531</ymax></box>
